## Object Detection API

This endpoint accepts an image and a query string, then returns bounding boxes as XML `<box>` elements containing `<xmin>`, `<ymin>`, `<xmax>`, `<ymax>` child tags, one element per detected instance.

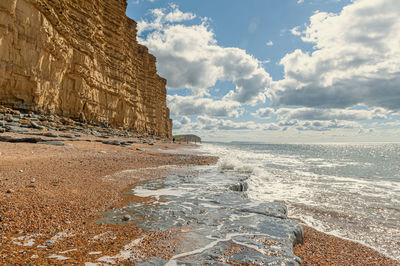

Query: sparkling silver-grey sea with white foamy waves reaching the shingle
<box><xmin>197</xmin><ymin>143</ymin><xmax>400</xmax><ymax>262</ymax></box>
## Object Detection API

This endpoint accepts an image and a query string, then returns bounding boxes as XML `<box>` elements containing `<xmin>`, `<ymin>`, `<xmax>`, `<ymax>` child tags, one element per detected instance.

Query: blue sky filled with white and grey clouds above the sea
<box><xmin>127</xmin><ymin>0</ymin><xmax>400</xmax><ymax>143</ymax></box>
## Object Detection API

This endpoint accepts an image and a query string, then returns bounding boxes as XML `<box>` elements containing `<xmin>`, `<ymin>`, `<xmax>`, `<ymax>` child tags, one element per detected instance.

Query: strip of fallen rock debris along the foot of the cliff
<box><xmin>0</xmin><ymin>106</ymin><xmax>160</xmax><ymax>146</ymax></box>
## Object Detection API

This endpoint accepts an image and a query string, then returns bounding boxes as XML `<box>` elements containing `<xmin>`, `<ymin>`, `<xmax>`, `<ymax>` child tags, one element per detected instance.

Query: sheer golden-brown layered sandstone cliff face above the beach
<box><xmin>0</xmin><ymin>0</ymin><xmax>172</xmax><ymax>138</ymax></box>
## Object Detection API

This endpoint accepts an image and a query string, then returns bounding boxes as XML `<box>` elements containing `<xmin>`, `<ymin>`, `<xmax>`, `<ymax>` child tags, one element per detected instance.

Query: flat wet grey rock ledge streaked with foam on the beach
<box><xmin>98</xmin><ymin>168</ymin><xmax>303</xmax><ymax>265</ymax></box>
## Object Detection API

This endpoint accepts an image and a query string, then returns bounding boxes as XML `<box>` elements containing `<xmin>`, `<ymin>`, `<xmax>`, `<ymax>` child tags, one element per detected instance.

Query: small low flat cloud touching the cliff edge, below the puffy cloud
<box><xmin>167</xmin><ymin>95</ymin><xmax>243</xmax><ymax>117</ymax></box>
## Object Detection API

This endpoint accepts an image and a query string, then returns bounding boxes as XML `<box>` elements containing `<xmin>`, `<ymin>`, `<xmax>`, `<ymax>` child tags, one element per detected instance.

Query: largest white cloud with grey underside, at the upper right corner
<box><xmin>270</xmin><ymin>0</ymin><xmax>400</xmax><ymax>110</ymax></box>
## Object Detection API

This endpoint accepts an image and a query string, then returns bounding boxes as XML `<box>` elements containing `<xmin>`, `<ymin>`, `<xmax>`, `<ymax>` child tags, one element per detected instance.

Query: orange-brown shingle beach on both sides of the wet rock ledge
<box><xmin>0</xmin><ymin>134</ymin><xmax>399</xmax><ymax>265</ymax></box>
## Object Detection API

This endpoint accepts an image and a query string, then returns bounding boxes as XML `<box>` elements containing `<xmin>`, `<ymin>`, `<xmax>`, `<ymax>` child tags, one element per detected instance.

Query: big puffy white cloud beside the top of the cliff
<box><xmin>138</xmin><ymin>6</ymin><xmax>271</xmax><ymax>104</ymax></box>
